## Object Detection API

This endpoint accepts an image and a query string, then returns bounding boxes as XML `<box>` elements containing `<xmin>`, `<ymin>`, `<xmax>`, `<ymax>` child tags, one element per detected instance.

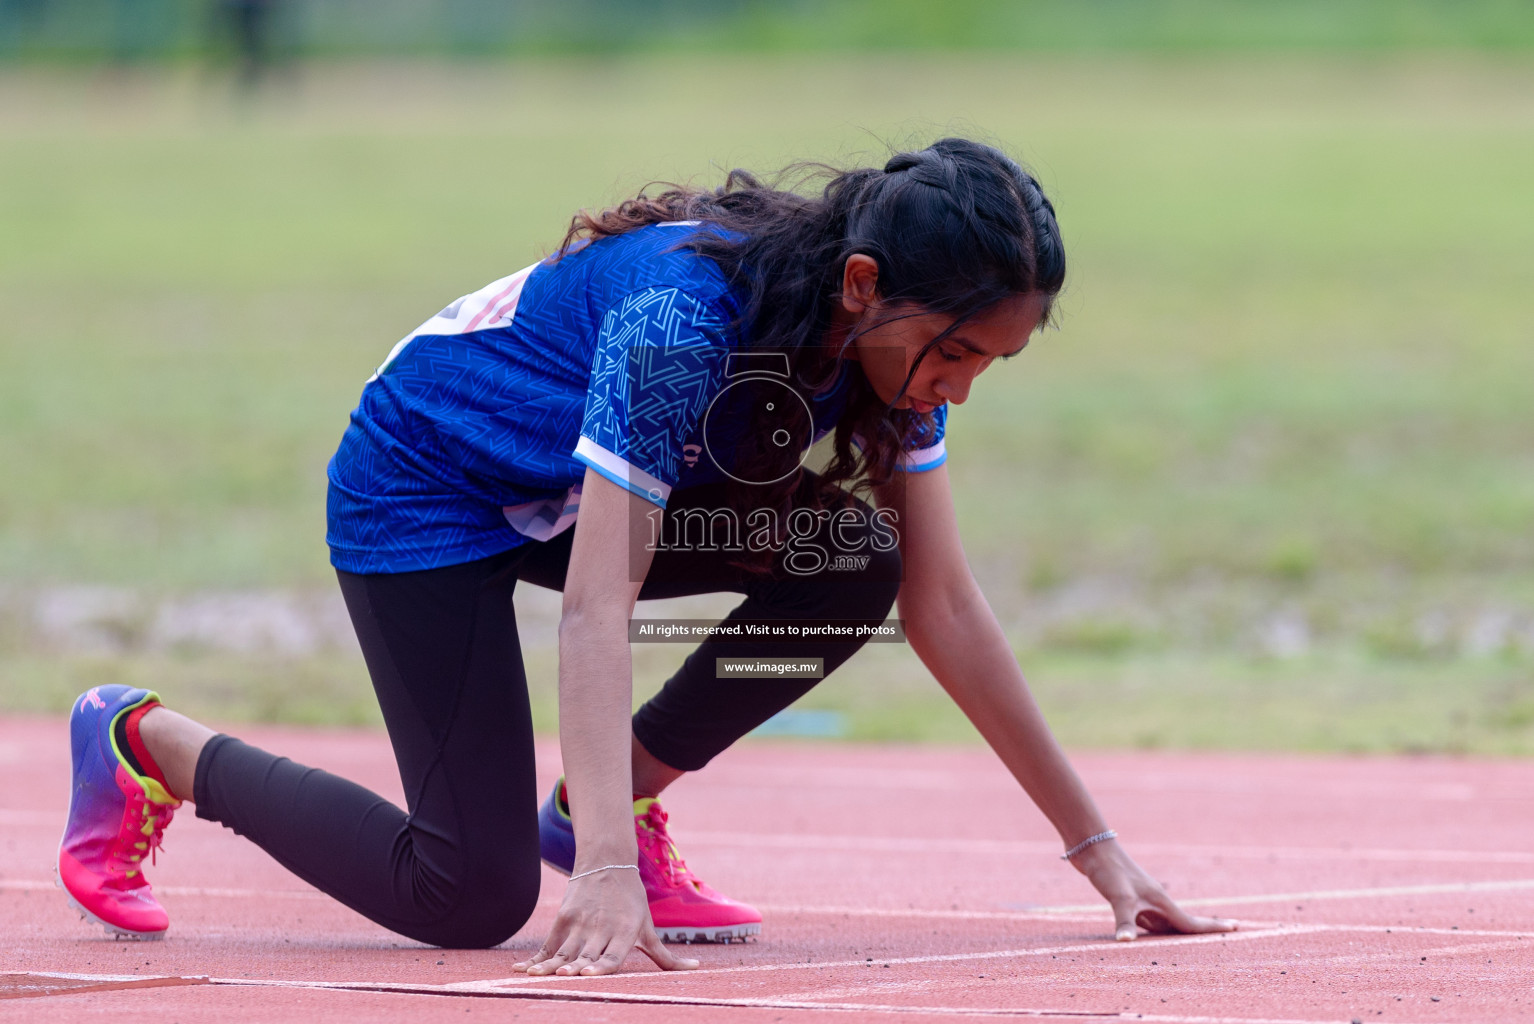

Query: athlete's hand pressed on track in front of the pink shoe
<box><xmin>512</xmin><ymin>869</ymin><xmax>698</xmax><ymax>976</ymax></box>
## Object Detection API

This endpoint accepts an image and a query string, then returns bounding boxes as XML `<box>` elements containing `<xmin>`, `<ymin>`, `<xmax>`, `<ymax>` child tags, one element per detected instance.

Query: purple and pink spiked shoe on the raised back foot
<box><xmin>58</xmin><ymin>687</ymin><xmax>181</xmax><ymax>938</ymax></box>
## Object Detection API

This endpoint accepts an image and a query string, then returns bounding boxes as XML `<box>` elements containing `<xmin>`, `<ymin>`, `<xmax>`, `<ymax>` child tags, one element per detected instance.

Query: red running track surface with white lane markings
<box><xmin>0</xmin><ymin>717</ymin><xmax>1534</xmax><ymax>1024</ymax></box>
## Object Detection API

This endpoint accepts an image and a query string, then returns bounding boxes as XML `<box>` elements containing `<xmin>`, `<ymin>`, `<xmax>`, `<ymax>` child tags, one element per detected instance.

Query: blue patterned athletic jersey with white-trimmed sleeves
<box><xmin>327</xmin><ymin>222</ymin><xmax>946</xmax><ymax>573</ymax></box>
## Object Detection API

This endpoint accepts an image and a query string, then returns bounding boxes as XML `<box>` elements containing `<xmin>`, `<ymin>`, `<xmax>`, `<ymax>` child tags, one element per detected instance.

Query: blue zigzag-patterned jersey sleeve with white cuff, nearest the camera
<box><xmin>575</xmin><ymin>288</ymin><xmax>735</xmax><ymax>509</ymax></box>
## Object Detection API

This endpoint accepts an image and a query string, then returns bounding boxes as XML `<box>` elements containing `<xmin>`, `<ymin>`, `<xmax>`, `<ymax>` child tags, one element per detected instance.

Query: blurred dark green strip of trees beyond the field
<box><xmin>0</xmin><ymin>0</ymin><xmax>1534</xmax><ymax>63</ymax></box>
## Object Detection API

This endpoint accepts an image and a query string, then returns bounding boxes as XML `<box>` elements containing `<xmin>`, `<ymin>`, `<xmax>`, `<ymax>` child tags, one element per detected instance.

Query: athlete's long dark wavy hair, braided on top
<box><xmin>560</xmin><ymin>138</ymin><xmax>1065</xmax><ymax>570</ymax></box>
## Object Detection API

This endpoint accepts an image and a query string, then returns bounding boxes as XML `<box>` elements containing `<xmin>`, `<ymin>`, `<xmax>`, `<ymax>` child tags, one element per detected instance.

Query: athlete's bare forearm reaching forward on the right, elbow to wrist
<box><xmin>900</xmin><ymin>573</ymin><xmax>1108</xmax><ymax>845</ymax></box>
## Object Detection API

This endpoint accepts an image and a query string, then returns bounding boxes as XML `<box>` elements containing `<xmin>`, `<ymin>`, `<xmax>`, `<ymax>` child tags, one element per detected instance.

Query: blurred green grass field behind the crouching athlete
<box><xmin>0</xmin><ymin>55</ymin><xmax>1534</xmax><ymax>753</ymax></box>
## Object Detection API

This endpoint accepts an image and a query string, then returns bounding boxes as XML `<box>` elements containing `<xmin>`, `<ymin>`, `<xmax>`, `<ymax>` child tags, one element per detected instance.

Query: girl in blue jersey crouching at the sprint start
<box><xmin>58</xmin><ymin>139</ymin><xmax>1233</xmax><ymax>975</ymax></box>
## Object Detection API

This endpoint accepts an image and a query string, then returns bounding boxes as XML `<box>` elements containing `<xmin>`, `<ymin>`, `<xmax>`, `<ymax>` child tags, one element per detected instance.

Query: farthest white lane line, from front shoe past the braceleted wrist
<box><xmin>683</xmin><ymin>831</ymin><xmax>1534</xmax><ymax>865</ymax></box>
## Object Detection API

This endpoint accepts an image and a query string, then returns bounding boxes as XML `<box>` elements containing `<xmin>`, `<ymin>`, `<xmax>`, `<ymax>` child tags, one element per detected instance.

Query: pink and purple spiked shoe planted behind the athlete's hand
<box><xmin>538</xmin><ymin>779</ymin><xmax>762</xmax><ymax>943</ymax></box>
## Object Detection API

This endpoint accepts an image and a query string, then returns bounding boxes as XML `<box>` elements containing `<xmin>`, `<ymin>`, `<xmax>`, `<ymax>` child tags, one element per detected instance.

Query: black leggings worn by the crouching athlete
<box><xmin>193</xmin><ymin>475</ymin><xmax>900</xmax><ymax>947</ymax></box>
